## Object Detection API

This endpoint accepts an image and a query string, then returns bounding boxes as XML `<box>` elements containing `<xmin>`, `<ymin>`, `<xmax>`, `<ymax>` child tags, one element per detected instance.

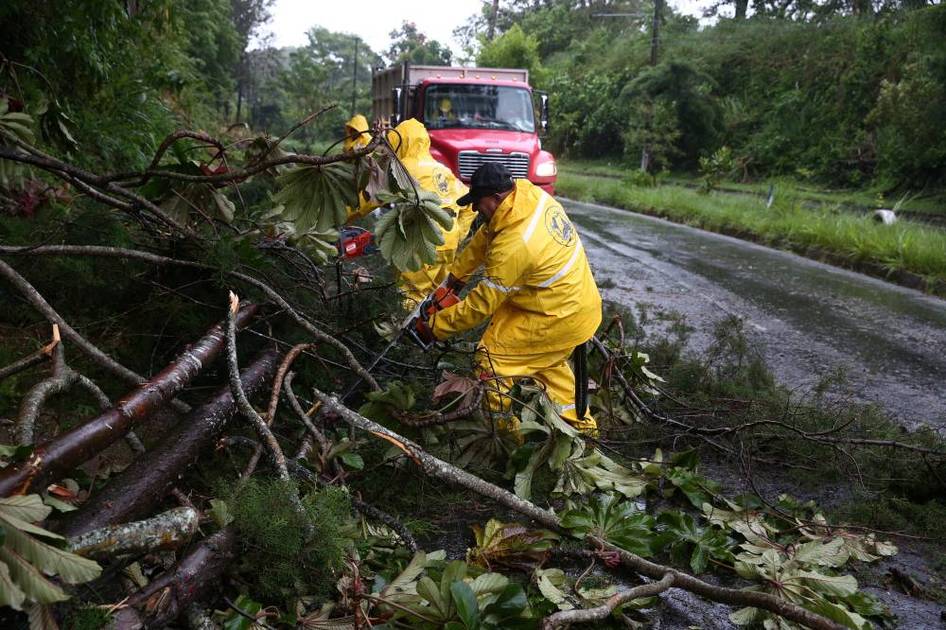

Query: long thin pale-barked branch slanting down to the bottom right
<box><xmin>315</xmin><ymin>390</ymin><xmax>844</xmax><ymax>630</ymax></box>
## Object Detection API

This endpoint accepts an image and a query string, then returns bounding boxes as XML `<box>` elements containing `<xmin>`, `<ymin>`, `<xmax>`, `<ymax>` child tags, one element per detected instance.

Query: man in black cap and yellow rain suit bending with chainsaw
<box><xmin>415</xmin><ymin>163</ymin><xmax>601</xmax><ymax>432</ymax></box>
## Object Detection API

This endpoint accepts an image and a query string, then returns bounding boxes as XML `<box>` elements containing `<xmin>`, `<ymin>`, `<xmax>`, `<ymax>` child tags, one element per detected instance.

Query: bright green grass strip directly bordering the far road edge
<box><xmin>557</xmin><ymin>171</ymin><xmax>946</xmax><ymax>292</ymax></box>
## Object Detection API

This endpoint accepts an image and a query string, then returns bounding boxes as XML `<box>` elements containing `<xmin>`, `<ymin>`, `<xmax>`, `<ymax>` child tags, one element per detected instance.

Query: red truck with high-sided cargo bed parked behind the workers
<box><xmin>371</xmin><ymin>63</ymin><xmax>557</xmax><ymax>194</ymax></box>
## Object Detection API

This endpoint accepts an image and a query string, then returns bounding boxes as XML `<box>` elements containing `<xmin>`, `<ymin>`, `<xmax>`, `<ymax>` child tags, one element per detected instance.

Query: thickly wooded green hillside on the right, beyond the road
<box><xmin>476</xmin><ymin>0</ymin><xmax>946</xmax><ymax>189</ymax></box>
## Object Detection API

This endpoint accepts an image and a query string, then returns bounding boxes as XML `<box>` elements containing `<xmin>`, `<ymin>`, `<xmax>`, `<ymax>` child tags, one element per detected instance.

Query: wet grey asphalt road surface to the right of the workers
<box><xmin>562</xmin><ymin>199</ymin><xmax>946</xmax><ymax>434</ymax></box>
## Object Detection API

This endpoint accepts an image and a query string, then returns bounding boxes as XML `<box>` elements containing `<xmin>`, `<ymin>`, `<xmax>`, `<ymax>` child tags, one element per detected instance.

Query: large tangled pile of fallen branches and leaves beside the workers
<box><xmin>0</xmin><ymin>106</ymin><xmax>936</xmax><ymax>628</ymax></box>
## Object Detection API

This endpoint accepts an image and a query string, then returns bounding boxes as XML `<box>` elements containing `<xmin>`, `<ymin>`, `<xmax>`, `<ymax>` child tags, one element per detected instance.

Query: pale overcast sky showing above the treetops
<box><xmin>251</xmin><ymin>0</ymin><xmax>709</xmax><ymax>54</ymax></box>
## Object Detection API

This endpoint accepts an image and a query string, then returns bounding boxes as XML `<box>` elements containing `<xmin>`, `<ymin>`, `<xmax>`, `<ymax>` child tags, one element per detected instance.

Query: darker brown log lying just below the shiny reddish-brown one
<box><xmin>60</xmin><ymin>349</ymin><xmax>279</xmax><ymax>537</ymax></box>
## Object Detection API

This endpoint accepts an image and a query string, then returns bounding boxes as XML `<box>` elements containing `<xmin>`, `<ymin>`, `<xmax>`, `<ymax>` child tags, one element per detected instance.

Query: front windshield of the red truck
<box><xmin>424</xmin><ymin>84</ymin><xmax>535</xmax><ymax>133</ymax></box>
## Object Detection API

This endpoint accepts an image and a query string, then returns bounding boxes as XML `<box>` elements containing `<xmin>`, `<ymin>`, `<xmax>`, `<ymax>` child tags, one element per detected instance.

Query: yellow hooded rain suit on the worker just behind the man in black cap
<box><xmin>388</xmin><ymin>118</ymin><xmax>476</xmax><ymax>306</ymax></box>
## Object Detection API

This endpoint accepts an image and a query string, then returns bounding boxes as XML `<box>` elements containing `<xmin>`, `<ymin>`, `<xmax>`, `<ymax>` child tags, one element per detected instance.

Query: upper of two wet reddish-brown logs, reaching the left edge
<box><xmin>0</xmin><ymin>307</ymin><xmax>257</xmax><ymax>497</ymax></box>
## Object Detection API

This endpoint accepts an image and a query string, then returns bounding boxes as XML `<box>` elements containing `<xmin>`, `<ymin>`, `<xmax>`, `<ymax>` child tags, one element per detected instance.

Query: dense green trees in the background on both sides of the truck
<box><xmin>0</xmin><ymin>0</ymin><xmax>946</xmax><ymax>196</ymax></box>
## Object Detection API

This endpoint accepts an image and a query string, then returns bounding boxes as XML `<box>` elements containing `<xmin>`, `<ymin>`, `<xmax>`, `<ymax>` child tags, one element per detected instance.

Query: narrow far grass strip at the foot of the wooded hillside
<box><xmin>558</xmin><ymin>160</ymin><xmax>946</xmax><ymax>215</ymax></box>
